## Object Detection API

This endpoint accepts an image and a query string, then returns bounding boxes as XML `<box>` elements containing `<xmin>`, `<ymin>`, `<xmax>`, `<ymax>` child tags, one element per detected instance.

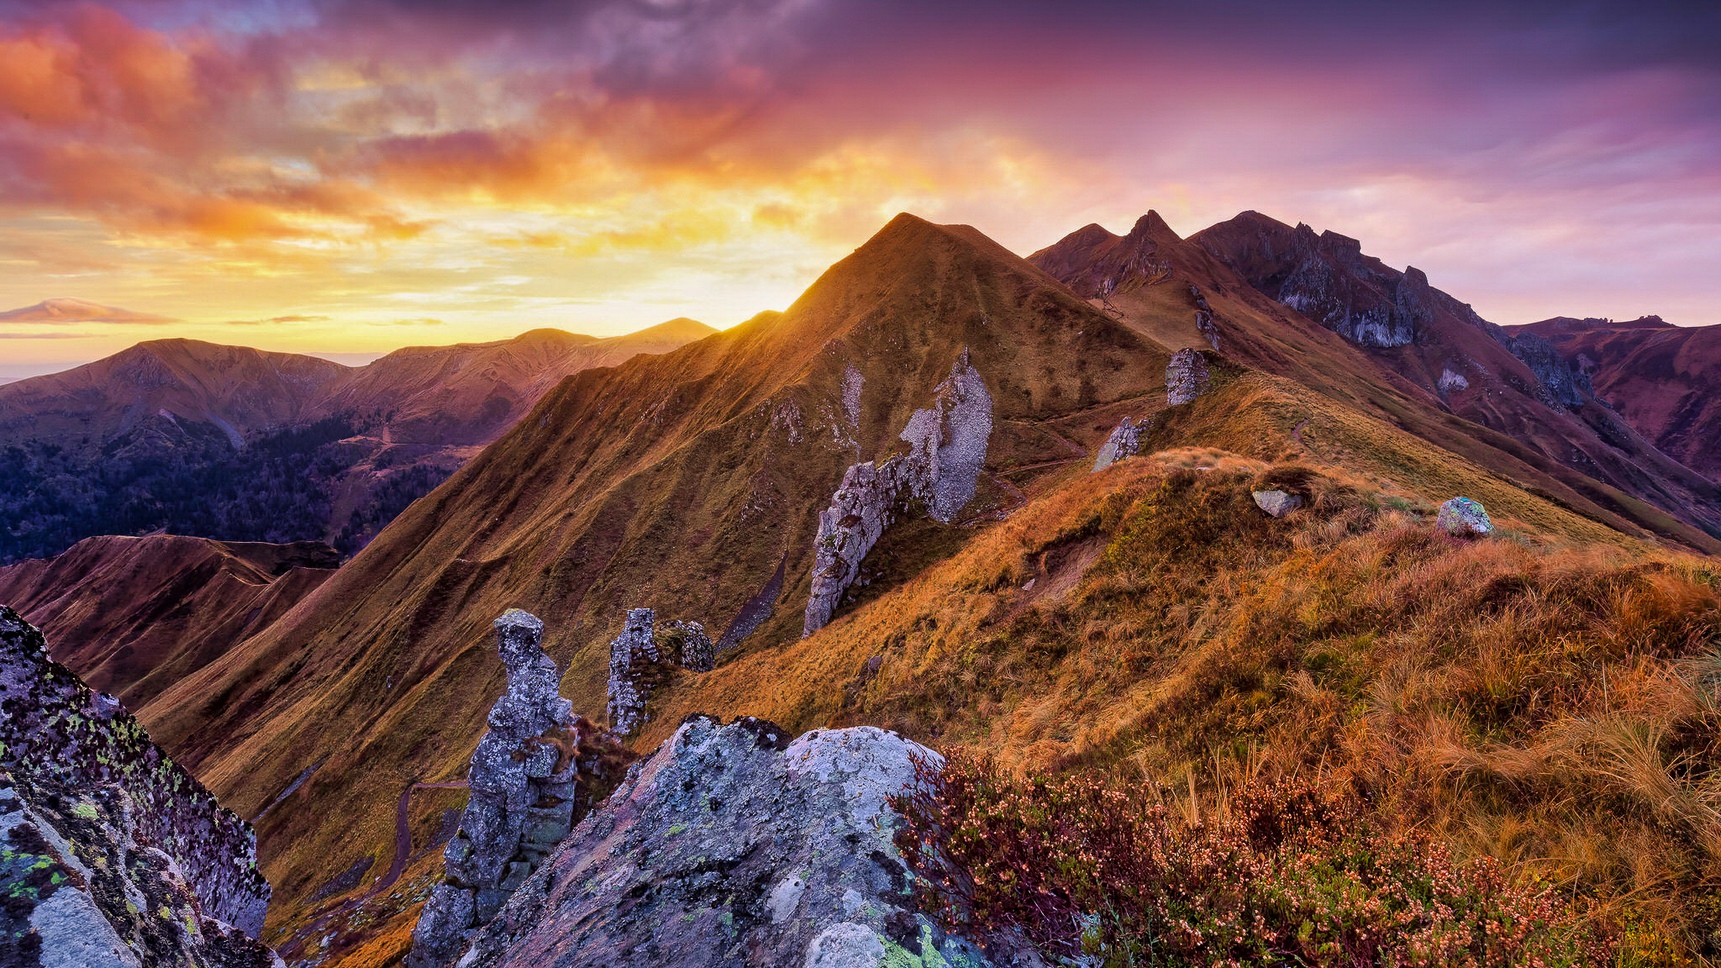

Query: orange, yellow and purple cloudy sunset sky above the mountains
<box><xmin>0</xmin><ymin>0</ymin><xmax>1721</xmax><ymax>375</ymax></box>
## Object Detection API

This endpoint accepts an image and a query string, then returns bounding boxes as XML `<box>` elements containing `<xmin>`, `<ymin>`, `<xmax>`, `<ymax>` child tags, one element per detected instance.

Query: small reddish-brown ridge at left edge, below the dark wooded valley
<box><xmin>0</xmin><ymin>534</ymin><xmax>341</xmax><ymax>710</ymax></box>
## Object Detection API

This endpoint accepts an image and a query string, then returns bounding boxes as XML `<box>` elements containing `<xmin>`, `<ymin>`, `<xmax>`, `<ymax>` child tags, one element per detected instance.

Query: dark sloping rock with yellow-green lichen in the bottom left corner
<box><xmin>0</xmin><ymin>606</ymin><xmax>281</xmax><ymax>968</ymax></box>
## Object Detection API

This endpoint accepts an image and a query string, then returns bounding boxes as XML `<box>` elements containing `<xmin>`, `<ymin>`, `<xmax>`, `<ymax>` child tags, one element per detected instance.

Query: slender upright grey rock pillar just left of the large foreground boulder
<box><xmin>406</xmin><ymin>608</ymin><xmax>585</xmax><ymax>968</ymax></box>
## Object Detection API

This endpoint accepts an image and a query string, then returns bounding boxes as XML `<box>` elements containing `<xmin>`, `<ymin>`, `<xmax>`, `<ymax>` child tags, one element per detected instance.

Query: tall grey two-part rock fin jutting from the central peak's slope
<box><xmin>802</xmin><ymin>350</ymin><xmax>991</xmax><ymax>636</ymax></box>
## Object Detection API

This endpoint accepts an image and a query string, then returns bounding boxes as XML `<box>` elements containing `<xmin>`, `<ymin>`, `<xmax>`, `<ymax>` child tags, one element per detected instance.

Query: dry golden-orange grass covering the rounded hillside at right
<box><xmin>645</xmin><ymin>437</ymin><xmax>1721</xmax><ymax>963</ymax></box>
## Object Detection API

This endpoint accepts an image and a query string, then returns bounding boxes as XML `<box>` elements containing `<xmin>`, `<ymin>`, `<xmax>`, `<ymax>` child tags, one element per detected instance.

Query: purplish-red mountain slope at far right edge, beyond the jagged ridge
<box><xmin>1506</xmin><ymin>315</ymin><xmax>1721</xmax><ymax>481</ymax></box>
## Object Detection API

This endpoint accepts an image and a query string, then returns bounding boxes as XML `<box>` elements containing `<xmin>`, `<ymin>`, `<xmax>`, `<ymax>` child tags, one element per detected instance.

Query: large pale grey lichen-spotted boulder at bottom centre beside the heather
<box><xmin>461</xmin><ymin>717</ymin><xmax>986</xmax><ymax>968</ymax></box>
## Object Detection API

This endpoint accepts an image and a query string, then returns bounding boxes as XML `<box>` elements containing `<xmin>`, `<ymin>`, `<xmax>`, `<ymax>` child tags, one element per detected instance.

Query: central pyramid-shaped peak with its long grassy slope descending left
<box><xmin>127</xmin><ymin>215</ymin><xmax>1167</xmax><ymax>957</ymax></box>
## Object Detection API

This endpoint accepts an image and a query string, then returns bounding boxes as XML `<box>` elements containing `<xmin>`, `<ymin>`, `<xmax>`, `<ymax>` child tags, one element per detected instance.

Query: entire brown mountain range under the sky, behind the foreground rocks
<box><xmin>0</xmin><ymin>212</ymin><xmax>1721</xmax><ymax>965</ymax></box>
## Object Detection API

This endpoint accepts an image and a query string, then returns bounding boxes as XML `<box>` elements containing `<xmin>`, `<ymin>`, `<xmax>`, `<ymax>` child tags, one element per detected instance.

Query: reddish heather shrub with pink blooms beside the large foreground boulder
<box><xmin>897</xmin><ymin>751</ymin><xmax>1613</xmax><ymax>966</ymax></box>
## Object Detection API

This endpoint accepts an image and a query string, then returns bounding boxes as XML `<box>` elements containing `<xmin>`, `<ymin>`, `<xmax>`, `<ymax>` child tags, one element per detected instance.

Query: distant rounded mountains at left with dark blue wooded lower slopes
<box><xmin>0</xmin><ymin>320</ymin><xmax>714</xmax><ymax>563</ymax></box>
